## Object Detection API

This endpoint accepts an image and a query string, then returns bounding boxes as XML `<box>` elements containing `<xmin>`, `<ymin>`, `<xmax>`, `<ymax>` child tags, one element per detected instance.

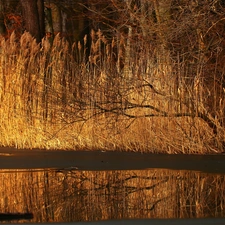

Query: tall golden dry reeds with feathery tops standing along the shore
<box><xmin>0</xmin><ymin>33</ymin><xmax>224</xmax><ymax>154</ymax></box>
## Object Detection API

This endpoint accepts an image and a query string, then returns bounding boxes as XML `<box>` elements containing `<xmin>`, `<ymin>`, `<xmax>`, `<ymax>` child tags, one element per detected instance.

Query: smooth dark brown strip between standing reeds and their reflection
<box><xmin>0</xmin><ymin>148</ymin><xmax>225</xmax><ymax>173</ymax></box>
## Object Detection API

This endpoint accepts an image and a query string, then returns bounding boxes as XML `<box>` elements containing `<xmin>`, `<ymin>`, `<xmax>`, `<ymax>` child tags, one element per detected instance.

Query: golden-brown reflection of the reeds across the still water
<box><xmin>0</xmin><ymin>170</ymin><xmax>225</xmax><ymax>222</ymax></box>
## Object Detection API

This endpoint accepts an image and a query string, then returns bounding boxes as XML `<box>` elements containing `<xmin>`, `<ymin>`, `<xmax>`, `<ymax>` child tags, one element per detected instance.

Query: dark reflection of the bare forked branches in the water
<box><xmin>59</xmin><ymin>171</ymin><xmax>169</xmax><ymax>216</ymax></box>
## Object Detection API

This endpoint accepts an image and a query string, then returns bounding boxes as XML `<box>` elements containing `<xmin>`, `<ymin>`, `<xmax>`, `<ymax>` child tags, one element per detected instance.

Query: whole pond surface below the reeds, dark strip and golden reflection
<box><xmin>0</xmin><ymin>149</ymin><xmax>225</xmax><ymax>224</ymax></box>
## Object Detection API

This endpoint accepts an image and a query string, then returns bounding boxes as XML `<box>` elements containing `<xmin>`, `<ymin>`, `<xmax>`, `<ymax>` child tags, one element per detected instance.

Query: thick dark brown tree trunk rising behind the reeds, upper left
<box><xmin>20</xmin><ymin>0</ymin><xmax>43</xmax><ymax>42</ymax></box>
